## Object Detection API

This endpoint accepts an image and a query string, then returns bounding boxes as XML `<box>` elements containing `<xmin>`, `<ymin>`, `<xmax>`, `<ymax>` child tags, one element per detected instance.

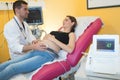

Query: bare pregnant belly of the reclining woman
<box><xmin>42</xmin><ymin>39</ymin><xmax>60</xmax><ymax>53</ymax></box>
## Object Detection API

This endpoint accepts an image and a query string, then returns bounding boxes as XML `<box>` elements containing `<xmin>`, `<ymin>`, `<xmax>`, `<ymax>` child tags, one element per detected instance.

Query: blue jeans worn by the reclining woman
<box><xmin>0</xmin><ymin>51</ymin><xmax>55</xmax><ymax>80</ymax></box>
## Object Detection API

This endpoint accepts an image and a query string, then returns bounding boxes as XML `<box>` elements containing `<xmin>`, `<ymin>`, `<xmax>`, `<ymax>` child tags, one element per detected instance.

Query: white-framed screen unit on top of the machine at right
<box><xmin>93</xmin><ymin>35</ymin><xmax>119</xmax><ymax>55</ymax></box>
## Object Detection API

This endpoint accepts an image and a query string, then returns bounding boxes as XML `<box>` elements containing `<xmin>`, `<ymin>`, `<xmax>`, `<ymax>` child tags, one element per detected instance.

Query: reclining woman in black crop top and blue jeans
<box><xmin>0</xmin><ymin>16</ymin><xmax>77</xmax><ymax>80</ymax></box>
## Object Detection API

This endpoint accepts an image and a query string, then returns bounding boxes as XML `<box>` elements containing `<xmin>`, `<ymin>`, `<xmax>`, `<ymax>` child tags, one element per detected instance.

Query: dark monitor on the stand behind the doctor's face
<box><xmin>25</xmin><ymin>7</ymin><xmax>43</xmax><ymax>25</ymax></box>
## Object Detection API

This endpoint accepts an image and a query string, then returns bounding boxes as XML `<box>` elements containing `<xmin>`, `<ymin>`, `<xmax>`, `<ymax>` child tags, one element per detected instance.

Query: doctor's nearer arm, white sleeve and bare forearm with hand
<box><xmin>4</xmin><ymin>25</ymin><xmax>46</xmax><ymax>54</ymax></box>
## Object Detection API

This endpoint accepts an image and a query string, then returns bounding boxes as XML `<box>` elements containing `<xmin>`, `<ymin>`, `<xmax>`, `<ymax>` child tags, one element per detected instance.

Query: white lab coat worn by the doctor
<box><xmin>4</xmin><ymin>16</ymin><xmax>36</xmax><ymax>59</ymax></box>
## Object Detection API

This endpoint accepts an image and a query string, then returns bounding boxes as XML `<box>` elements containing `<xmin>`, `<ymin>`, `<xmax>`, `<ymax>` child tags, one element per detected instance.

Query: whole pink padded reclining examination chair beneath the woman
<box><xmin>31</xmin><ymin>17</ymin><xmax>102</xmax><ymax>80</ymax></box>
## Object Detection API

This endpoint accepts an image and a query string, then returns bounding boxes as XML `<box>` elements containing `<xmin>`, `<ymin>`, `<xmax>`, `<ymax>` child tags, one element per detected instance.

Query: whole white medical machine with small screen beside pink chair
<box><xmin>86</xmin><ymin>35</ymin><xmax>120</xmax><ymax>80</ymax></box>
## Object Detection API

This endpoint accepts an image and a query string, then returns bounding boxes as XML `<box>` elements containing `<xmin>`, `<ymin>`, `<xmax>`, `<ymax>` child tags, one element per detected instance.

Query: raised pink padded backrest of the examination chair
<box><xmin>67</xmin><ymin>18</ymin><xmax>102</xmax><ymax>67</ymax></box>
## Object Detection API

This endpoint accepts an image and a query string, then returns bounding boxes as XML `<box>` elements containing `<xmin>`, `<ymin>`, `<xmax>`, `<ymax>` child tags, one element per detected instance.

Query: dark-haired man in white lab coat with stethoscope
<box><xmin>4</xmin><ymin>0</ymin><xmax>46</xmax><ymax>59</ymax></box>
